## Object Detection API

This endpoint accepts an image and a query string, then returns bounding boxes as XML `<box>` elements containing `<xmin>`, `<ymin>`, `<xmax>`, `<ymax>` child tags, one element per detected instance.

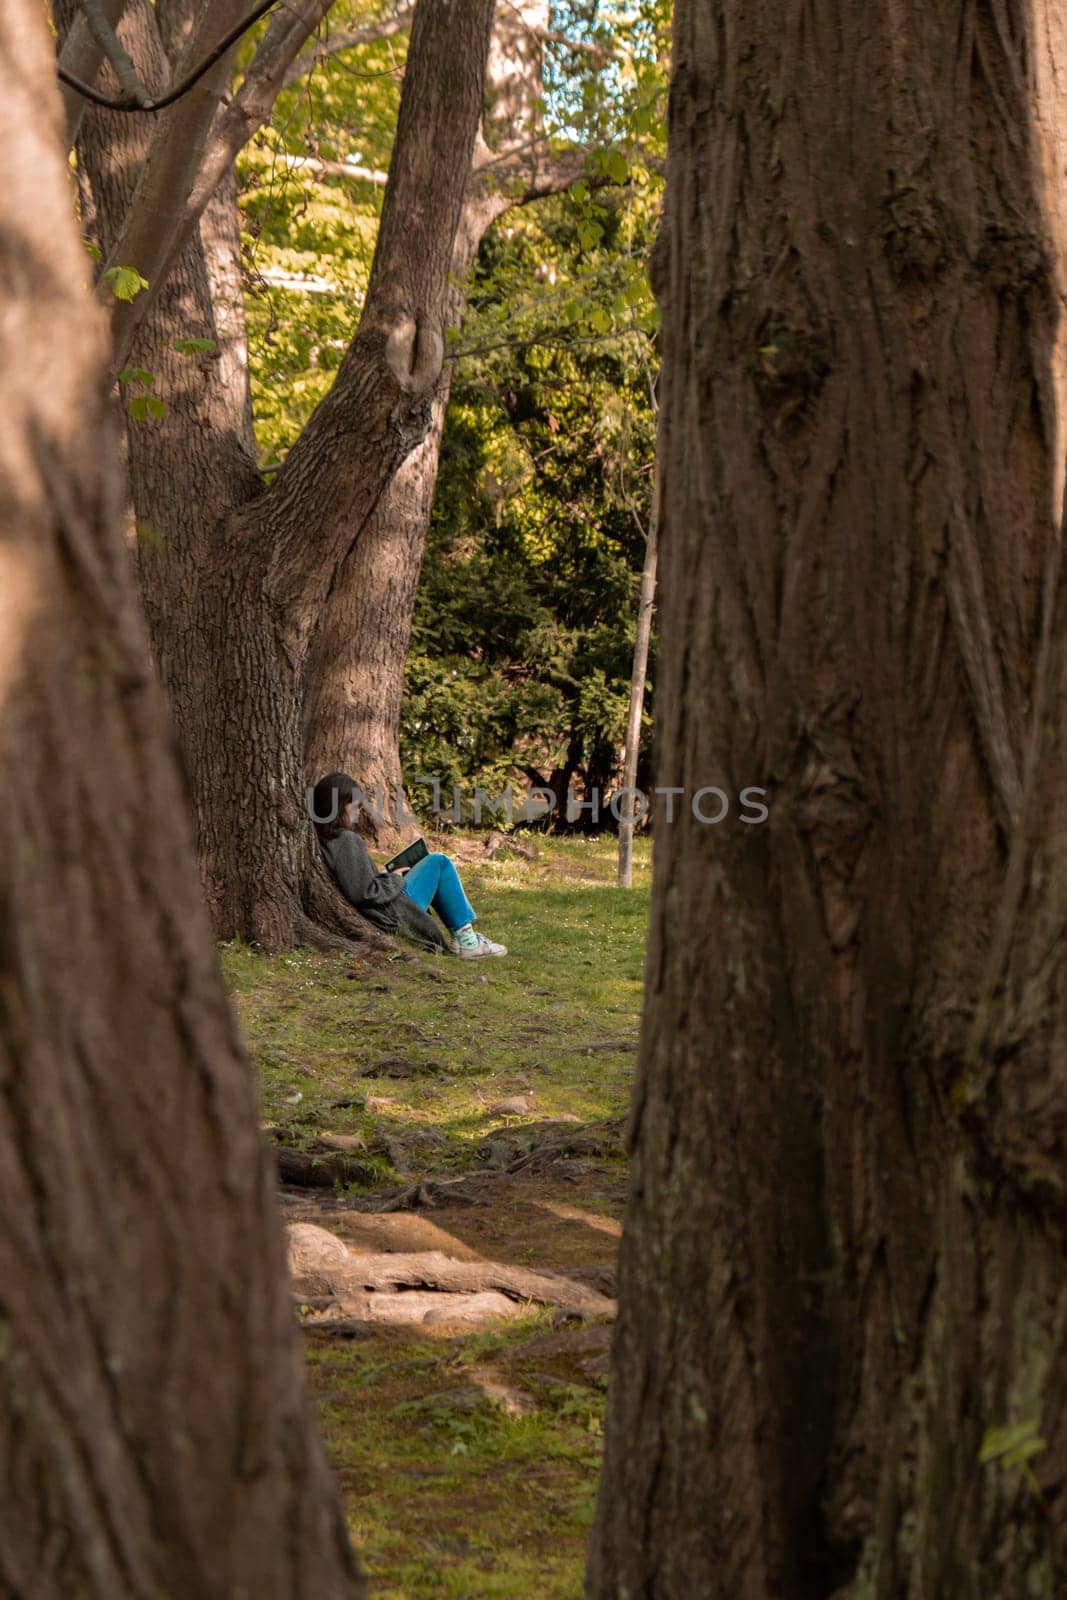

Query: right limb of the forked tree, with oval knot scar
<box><xmin>256</xmin><ymin>0</ymin><xmax>493</xmax><ymax>624</ymax></box>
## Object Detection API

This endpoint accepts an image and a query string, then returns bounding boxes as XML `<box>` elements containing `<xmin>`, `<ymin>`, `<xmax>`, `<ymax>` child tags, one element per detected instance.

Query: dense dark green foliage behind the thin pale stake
<box><xmin>402</xmin><ymin>180</ymin><xmax>656</xmax><ymax>806</ymax></box>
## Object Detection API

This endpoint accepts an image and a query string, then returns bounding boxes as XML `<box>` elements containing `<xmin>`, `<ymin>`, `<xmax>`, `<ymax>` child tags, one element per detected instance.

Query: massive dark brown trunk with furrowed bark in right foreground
<box><xmin>589</xmin><ymin>0</ymin><xmax>1067</xmax><ymax>1600</ymax></box>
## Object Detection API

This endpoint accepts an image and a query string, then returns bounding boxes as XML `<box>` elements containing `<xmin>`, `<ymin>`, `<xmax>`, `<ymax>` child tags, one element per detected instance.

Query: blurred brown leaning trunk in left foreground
<box><xmin>0</xmin><ymin>9</ymin><xmax>365</xmax><ymax>1600</ymax></box>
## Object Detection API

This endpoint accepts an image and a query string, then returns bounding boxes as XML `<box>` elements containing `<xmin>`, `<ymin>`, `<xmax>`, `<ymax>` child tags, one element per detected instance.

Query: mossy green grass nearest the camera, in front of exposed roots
<box><xmin>309</xmin><ymin>1318</ymin><xmax>603</xmax><ymax>1600</ymax></box>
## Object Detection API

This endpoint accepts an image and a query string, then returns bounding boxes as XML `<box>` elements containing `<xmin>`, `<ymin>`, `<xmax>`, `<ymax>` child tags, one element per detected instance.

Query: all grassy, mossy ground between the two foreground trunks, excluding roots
<box><xmin>222</xmin><ymin>838</ymin><xmax>649</xmax><ymax>1600</ymax></box>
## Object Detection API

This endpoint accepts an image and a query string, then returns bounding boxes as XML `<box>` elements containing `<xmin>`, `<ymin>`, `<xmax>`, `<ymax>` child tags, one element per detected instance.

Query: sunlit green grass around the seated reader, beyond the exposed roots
<box><xmin>222</xmin><ymin>838</ymin><xmax>649</xmax><ymax>1171</ymax></box>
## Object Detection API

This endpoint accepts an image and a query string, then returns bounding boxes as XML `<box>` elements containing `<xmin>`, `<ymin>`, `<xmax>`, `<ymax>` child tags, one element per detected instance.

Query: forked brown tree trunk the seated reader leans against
<box><xmin>73</xmin><ymin>0</ymin><xmax>491</xmax><ymax>949</ymax></box>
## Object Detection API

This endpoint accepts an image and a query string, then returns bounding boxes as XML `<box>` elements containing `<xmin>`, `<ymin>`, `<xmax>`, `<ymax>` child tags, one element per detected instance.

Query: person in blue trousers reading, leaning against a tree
<box><xmin>312</xmin><ymin>773</ymin><xmax>507</xmax><ymax>962</ymax></box>
